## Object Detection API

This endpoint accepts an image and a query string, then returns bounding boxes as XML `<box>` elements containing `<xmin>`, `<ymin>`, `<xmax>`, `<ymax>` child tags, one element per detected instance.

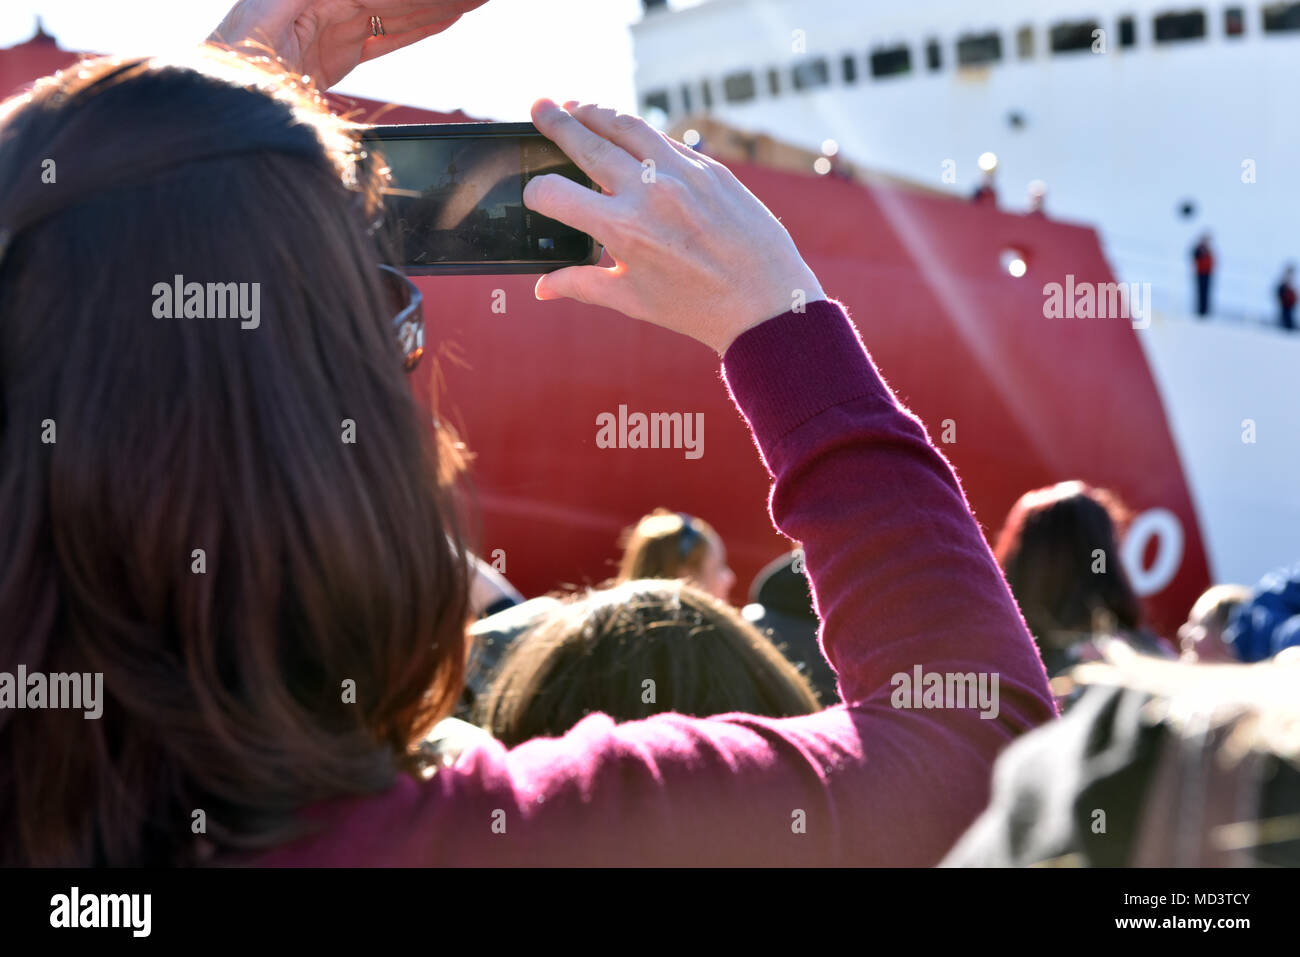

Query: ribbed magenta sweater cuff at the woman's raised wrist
<box><xmin>723</xmin><ymin>299</ymin><xmax>896</xmax><ymax>445</ymax></box>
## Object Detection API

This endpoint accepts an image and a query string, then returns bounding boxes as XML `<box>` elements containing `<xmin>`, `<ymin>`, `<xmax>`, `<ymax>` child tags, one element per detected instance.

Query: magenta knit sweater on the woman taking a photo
<box><xmin>245</xmin><ymin>302</ymin><xmax>1054</xmax><ymax>866</ymax></box>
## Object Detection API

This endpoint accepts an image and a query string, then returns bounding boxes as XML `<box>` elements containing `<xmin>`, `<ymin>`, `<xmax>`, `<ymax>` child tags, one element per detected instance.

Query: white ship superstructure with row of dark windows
<box><xmin>633</xmin><ymin>0</ymin><xmax>1300</xmax><ymax>320</ymax></box>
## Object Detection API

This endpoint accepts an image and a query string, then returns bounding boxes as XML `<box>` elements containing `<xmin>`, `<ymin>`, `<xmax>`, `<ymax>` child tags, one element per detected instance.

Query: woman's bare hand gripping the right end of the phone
<box><xmin>524</xmin><ymin>100</ymin><xmax>826</xmax><ymax>354</ymax></box>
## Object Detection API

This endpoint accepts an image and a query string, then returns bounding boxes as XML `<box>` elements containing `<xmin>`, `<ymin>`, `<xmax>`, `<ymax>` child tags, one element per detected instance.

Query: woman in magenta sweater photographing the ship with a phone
<box><xmin>0</xmin><ymin>0</ymin><xmax>1056</xmax><ymax>866</ymax></box>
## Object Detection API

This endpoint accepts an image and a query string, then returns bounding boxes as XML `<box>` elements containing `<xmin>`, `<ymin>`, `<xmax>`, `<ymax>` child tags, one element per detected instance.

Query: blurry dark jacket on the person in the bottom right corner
<box><xmin>944</xmin><ymin>681</ymin><xmax>1300</xmax><ymax>867</ymax></box>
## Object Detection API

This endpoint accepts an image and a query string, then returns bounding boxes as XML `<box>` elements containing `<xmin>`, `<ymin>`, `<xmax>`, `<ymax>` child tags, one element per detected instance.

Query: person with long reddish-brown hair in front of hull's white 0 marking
<box><xmin>995</xmin><ymin>481</ymin><xmax>1173</xmax><ymax>677</ymax></box>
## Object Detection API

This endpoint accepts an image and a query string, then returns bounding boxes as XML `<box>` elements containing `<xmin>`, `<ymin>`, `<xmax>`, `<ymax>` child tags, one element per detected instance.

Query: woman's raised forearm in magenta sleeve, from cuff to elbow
<box><xmin>724</xmin><ymin>302</ymin><xmax>1053</xmax><ymax>729</ymax></box>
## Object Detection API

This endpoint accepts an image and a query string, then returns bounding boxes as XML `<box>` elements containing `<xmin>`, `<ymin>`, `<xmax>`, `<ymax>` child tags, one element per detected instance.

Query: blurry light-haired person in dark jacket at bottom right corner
<box><xmin>944</xmin><ymin>655</ymin><xmax>1300</xmax><ymax>867</ymax></box>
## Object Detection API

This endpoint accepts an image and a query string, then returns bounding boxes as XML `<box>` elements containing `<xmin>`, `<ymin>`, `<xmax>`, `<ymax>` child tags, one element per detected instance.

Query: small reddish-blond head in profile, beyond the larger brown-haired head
<box><xmin>619</xmin><ymin>508</ymin><xmax>736</xmax><ymax>601</ymax></box>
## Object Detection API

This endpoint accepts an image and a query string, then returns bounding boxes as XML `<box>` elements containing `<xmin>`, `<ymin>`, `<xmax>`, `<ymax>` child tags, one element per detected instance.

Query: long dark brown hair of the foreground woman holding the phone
<box><xmin>0</xmin><ymin>53</ymin><xmax>465</xmax><ymax>865</ymax></box>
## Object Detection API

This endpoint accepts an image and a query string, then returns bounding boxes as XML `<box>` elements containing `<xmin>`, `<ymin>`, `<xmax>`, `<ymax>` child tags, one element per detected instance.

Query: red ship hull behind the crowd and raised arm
<box><xmin>408</xmin><ymin>159</ymin><xmax>1209</xmax><ymax>635</ymax></box>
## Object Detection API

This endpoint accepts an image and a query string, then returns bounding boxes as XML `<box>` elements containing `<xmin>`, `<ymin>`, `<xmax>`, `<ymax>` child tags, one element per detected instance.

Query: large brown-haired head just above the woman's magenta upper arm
<box><xmin>477</xmin><ymin>581</ymin><xmax>818</xmax><ymax>745</ymax></box>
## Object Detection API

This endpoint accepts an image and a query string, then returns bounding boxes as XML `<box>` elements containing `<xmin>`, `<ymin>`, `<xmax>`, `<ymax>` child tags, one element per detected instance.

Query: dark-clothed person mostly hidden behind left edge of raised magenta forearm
<box><xmin>741</xmin><ymin>549</ymin><xmax>840</xmax><ymax>705</ymax></box>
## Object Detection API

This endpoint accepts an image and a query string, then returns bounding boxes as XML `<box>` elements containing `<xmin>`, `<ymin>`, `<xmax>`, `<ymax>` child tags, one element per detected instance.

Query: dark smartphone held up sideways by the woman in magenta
<box><xmin>363</xmin><ymin>124</ymin><xmax>602</xmax><ymax>276</ymax></box>
